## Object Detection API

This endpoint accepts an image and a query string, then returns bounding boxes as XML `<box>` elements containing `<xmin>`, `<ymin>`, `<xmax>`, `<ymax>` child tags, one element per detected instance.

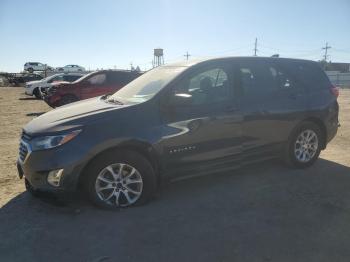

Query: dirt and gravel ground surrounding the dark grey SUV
<box><xmin>0</xmin><ymin>88</ymin><xmax>350</xmax><ymax>262</ymax></box>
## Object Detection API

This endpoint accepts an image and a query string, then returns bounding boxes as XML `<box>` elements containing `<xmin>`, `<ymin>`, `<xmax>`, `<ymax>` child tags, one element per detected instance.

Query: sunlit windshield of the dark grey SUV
<box><xmin>108</xmin><ymin>66</ymin><xmax>186</xmax><ymax>103</ymax></box>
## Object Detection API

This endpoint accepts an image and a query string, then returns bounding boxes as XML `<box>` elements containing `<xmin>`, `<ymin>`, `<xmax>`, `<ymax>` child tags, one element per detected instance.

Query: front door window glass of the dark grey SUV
<box><xmin>173</xmin><ymin>67</ymin><xmax>231</xmax><ymax>106</ymax></box>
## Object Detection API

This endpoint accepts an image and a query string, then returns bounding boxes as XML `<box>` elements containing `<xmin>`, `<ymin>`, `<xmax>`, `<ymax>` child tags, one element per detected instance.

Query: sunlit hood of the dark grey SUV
<box><xmin>23</xmin><ymin>97</ymin><xmax>129</xmax><ymax>136</ymax></box>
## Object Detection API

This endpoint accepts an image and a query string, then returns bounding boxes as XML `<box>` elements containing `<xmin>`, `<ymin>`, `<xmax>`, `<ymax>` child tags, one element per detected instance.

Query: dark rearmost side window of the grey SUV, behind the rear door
<box><xmin>280</xmin><ymin>61</ymin><xmax>331</xmax><ymax>89</ymax></box>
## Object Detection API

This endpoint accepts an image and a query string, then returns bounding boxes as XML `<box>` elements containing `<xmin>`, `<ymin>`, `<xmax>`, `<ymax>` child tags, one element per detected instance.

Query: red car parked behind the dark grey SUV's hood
<box><xmin>44</xmin><ymin>70</ymin><xmax>141</xmax><ymax>107</ymax></box>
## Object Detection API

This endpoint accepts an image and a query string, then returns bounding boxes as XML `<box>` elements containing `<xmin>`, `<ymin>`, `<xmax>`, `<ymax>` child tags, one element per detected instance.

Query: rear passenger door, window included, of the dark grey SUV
<box><xmin>238</xmin><ymin>59</ymin><xmax>306</xmax><ymax>160</ymax></box>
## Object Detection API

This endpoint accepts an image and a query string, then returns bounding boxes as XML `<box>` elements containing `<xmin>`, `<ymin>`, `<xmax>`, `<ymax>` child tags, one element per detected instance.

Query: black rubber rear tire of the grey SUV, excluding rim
<box><xmin>286</xmin><ymin>122</ymin><xmax>323</xmax><ymax>168</ymax></box>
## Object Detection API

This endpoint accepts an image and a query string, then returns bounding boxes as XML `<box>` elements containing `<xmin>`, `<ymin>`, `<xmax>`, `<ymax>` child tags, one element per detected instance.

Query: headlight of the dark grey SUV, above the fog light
<box><xmin>30</xmin><ymin>130</ymin><xmax>81</xmax><ymax>151</ymax></box>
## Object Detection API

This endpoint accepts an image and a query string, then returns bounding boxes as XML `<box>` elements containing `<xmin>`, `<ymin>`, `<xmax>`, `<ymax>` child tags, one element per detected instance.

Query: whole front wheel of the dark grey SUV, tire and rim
<box><xmin>83</xmin><ymin>150</ymin><xmax>156</xmax><ymax>209</ymax></box>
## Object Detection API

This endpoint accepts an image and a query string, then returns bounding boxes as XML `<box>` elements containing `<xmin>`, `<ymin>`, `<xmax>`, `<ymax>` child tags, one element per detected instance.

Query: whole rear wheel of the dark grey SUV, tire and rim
<box><xmin>285</xmin><ymin>121</ymin><xmax>324</xmax><ymax>168</ymax></box>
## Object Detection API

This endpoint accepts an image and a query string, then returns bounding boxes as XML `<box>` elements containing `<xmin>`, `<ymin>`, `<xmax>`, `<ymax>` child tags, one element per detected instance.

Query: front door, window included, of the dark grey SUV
<box><xmin>161</xmin><ymin>60</ymin><xmax>242</xmax><ymax>176</ymax></box>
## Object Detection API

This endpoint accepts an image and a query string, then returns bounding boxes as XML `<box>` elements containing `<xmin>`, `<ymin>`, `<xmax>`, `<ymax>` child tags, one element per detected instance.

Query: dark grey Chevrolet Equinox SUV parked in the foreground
<box><xmin>18</xmin><ymin>57</ymin><xmax>338</xmax><ymax>208</ymax></box>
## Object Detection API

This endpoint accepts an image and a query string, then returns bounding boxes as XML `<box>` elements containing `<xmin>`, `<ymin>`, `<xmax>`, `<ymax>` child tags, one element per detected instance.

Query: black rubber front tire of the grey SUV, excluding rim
<box><xmin>83</xmin><ymin>150</ymin><xmax>156</xmax><ymax>209</ymax></box>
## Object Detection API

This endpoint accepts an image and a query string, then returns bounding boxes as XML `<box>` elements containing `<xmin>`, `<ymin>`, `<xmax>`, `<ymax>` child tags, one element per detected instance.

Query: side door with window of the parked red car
<box><xmin>81</xmin><ymin>72</ymin><xmax>110</xmax><ymax>99</ymax></box>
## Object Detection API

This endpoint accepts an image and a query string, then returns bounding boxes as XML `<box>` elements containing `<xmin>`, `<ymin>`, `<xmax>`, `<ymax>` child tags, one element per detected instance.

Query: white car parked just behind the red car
<box><xmin>25</xmin><ymin>73</ymin><xmax>83</xmax><ymax>98</ymax></box>
